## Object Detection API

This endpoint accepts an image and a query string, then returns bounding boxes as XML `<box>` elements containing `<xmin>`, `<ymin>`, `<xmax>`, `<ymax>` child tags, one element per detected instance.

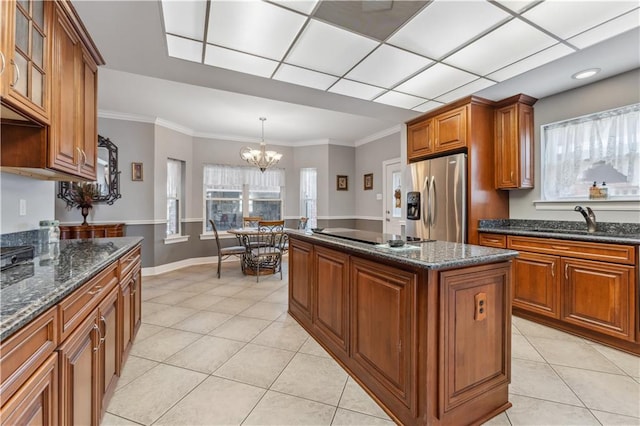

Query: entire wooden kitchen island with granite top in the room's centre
<box><xmin>289</xmin><ymin>230</ymin><xmax>517</xmax><ymax>425</ymax></box>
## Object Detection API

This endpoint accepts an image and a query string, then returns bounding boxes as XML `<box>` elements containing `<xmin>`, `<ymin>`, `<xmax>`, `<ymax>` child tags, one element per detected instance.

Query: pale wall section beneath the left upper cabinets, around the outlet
<box><xmin>0</xmin><ymin>173</ymin><xmax>56</xmax><ymax>234</ymax></box>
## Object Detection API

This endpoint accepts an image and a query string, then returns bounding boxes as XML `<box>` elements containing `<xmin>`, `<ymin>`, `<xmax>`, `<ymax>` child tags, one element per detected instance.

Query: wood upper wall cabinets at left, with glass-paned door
<box><xmin>0</xmin><ymin>0</ymin><xmax>104</xmax><ymax>181</ymax></box>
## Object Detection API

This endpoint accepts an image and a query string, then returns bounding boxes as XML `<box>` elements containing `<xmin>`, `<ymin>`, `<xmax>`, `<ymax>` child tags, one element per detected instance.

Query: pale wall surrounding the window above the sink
<box><xmin>509</xmin><ymin>69</ymin><xmax>640</xmax><ymax>223</ymax></box>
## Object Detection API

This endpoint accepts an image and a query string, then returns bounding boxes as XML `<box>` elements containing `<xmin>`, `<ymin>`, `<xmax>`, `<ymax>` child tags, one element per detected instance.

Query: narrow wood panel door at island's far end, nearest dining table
<box><xmin>289</xmin><ymin>238</ymin><xmax>314</xmax><ymax>327</ymax></box>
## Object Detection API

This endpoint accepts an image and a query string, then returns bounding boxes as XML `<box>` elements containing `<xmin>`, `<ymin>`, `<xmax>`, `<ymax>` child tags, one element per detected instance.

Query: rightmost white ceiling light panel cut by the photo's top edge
<box><xmin>522</xmin><ymin>1</ymin><xmax>638</xmax><ymax>39</ymax></box>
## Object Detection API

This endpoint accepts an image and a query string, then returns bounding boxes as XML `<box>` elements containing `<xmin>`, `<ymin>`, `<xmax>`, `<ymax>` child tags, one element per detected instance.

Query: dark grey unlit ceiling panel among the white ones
<box><xmin>313</xmin><ymin>0</ymin><xmax>428</xmax><ymax>41</ymax></box>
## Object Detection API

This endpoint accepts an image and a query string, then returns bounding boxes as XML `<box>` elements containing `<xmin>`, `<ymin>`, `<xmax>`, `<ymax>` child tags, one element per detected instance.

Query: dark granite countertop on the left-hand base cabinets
<box><xmin>0</xmin><ymin>237</ymin><xmax>142</xmax><ymax>340</ymax></box>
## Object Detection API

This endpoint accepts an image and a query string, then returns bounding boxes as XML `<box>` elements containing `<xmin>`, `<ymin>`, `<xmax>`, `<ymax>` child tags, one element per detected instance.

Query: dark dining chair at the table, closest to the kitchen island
<box><xmin>242</xmin><ymin>220</ymin><xmax>287</xmax><ymax>282</ymax></box>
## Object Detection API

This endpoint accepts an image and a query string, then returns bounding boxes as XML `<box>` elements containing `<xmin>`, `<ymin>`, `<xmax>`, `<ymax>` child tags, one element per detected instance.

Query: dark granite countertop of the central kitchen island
<box><xmin>288</xmin><ymin>229</ymin><xmax>518</xmax><ymax>269</ymax></box>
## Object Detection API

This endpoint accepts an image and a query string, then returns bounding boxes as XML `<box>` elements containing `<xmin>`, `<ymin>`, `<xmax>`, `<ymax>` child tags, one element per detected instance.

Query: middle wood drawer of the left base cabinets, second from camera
<box><xmin>58</xmin><ymin>262</ymin><xmax>118</xmax><ymax>341</ymax></box>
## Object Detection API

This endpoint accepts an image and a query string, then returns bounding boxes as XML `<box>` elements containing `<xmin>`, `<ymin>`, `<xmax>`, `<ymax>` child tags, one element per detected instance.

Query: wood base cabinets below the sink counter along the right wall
<box><xmin>480</xmin><ymin>233</ymin><xmax>640</xmax><ymax>354</ymax></box>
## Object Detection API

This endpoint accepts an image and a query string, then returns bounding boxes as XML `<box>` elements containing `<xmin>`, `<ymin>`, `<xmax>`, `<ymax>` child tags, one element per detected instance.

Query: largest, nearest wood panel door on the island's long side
<box><xmin>350</xmin><ymin>258</ymin><xmax>417</xmax><ymax>416</ymax></box>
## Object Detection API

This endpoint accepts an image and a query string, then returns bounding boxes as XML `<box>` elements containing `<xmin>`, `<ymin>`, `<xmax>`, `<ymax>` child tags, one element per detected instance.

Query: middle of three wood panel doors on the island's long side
<box><xmin>313</xmin><ymin>246</ymin><xmax>349</xmax><ymax>359</ymax></box>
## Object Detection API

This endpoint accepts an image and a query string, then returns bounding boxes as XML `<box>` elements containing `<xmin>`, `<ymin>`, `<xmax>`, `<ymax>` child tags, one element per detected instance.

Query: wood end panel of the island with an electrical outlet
<box><xmin>438</xmin><ymin>262</ymin><xmax>511</xmax><ymax>424</ymax></box>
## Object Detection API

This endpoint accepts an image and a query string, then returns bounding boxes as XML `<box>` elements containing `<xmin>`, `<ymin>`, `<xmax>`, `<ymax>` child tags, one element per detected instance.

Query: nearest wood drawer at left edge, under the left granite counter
<box><xmin>0</xmin><ymin>307</ymin><xmax>59</xmax><ymax>405</ymax></box>
